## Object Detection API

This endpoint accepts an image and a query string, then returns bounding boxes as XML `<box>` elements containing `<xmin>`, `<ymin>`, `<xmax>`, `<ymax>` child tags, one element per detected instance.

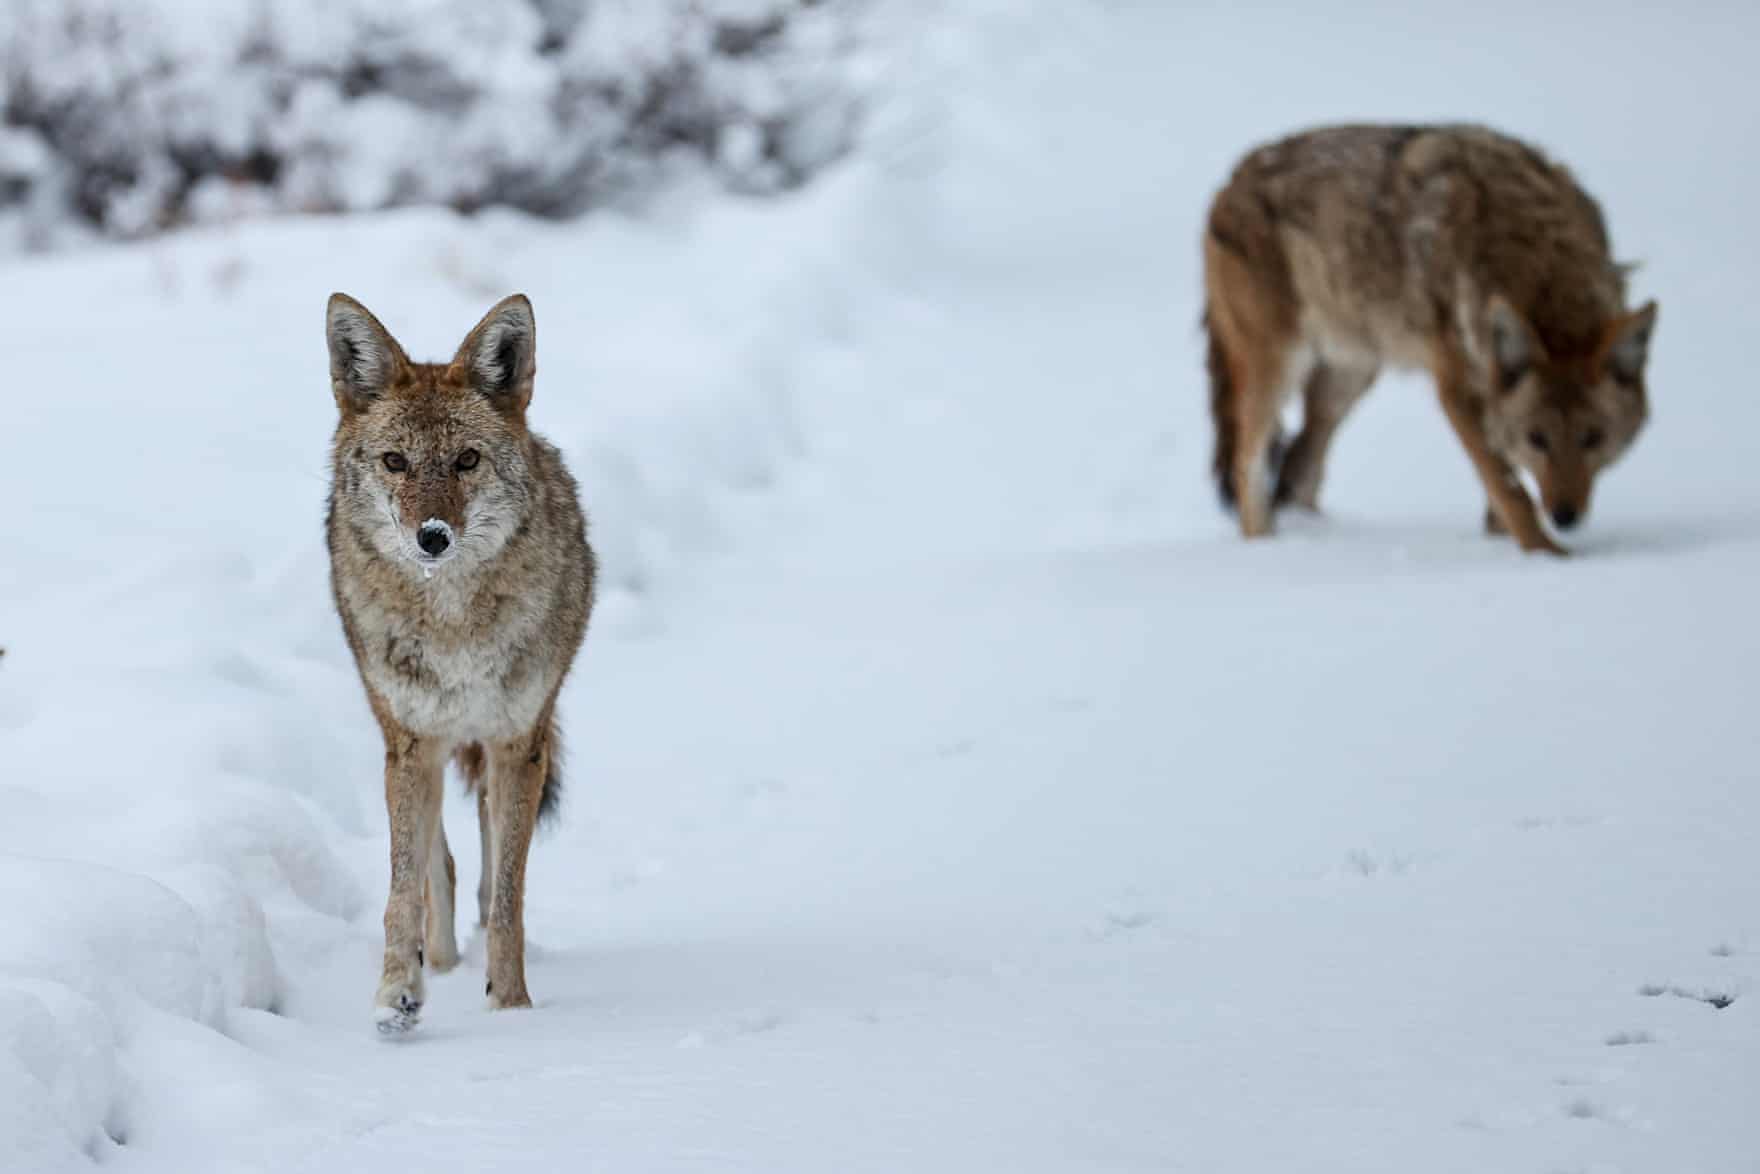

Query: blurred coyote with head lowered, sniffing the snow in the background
<box><xmin>1204</xmin><ymin>127</ymin><xmax>1656</xmax><ymax>554</ymax></box>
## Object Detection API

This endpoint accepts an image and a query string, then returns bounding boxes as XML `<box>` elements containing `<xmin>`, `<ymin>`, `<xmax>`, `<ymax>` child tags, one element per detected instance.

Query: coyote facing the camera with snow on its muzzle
<box><xmin>326</xmin><ymin>294</ymin><xmax>595</xmax><ymax>1033</ymax></box>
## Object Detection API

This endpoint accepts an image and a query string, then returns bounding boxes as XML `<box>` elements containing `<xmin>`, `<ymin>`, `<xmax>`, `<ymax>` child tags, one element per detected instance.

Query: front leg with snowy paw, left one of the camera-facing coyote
<box><xmin>373</xmin><ymin>720</ymin><xmax>445</xmax><ymax>1031</ymax></box>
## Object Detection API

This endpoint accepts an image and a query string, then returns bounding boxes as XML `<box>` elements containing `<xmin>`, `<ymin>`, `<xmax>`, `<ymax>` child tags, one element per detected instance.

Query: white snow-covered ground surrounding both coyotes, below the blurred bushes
<box><xmin>0</xmin><ymin>0</ymin><xmax>1760</xmax><ymax>1174</ymax></box>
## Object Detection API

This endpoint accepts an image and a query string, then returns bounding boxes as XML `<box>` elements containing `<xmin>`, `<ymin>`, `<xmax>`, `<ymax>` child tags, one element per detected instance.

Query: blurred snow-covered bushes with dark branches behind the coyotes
<box><xmin>0</xmin><ymin>0</ymin><xmax>857</xmax><ymax>248</ymax></box>
